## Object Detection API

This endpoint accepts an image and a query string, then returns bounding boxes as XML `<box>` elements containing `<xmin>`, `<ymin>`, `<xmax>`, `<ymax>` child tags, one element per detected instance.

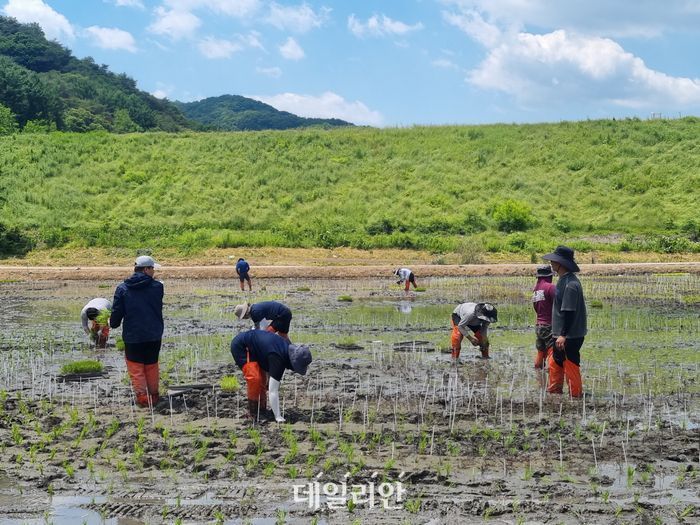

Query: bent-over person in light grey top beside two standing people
<box><xmin>452</xmin><ymin>303</ymin><xmax>498</xmax><ymax>362</ymax></box>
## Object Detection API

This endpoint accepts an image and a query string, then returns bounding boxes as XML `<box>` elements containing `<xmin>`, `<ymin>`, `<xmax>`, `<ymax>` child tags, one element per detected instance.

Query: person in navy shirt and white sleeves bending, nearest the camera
<box><xmin>231</xmin><ymin>330</ymin><xmax>311</xmax><ymax>423</ymax></box>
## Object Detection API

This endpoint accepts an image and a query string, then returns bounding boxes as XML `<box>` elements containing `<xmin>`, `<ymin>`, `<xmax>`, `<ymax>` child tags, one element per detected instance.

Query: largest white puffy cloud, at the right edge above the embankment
<box><xmin>467</xmin><ymin>30</ymin><xmax>700</xmax><ymax>108</ymax></box>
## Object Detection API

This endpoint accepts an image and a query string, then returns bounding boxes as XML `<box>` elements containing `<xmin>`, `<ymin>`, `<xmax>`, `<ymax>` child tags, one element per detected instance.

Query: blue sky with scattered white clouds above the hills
<box><xmin>5</xmin><ymin>0</ymin><xmax>700</xmax><ymax>126</ymax></box>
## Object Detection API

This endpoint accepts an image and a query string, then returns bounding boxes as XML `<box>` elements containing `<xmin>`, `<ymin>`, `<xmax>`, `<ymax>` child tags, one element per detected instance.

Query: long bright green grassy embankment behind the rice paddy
<box><xmin>0</xmin><ymin>118</ymin><xmax>700</xmax><ymax>257</ymax></box>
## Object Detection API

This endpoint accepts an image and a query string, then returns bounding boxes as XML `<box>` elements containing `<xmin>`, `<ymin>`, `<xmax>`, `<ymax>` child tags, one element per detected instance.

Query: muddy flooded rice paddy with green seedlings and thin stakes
<box><xmin>0</xmin><ymin>275</ymin><xmax>700</xmax><ymax>524</ymax></box>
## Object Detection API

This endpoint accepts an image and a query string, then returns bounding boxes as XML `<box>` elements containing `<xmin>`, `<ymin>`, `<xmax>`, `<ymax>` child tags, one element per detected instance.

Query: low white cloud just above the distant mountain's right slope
<box><xmin>250</xmin><ymin>91</ymin><xmax>384</xmax><ymax>126</ymax></box>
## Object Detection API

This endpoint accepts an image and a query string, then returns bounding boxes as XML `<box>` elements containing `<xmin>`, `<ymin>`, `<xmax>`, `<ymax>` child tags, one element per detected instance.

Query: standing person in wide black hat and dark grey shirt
<box><xmin>542</xmin><ymin>246</ymin><xmax>588</xmax><ymax>397</ymax></box>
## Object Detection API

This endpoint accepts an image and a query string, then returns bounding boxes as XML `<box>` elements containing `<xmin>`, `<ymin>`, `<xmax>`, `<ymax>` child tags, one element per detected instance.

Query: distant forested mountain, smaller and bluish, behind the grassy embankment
<box><xmin>175</xmin><ymin>95</ymin><xmax>352</xmax><ymax>131</ymax></box>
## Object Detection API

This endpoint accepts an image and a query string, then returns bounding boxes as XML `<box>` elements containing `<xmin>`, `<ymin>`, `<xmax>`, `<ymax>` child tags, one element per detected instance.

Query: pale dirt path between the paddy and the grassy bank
<box><xmin>0</xmin><ymin>262</ymin><xmax>700</xmax><ymax>281</ymax></box>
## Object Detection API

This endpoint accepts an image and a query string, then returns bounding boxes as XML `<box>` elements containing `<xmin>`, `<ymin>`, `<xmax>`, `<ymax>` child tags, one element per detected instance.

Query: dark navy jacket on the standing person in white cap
<box><xmin>109</xmin><ymin>272</ymin><xmax>163</xmax><ymax>343</ymax></box>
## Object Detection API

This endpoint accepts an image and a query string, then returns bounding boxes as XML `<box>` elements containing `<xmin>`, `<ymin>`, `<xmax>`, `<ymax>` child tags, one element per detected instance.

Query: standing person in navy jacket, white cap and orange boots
<box><xmin>109</xmin><ymin>255</ymin><xmax>163</xmax><ymax>407</ymax></box>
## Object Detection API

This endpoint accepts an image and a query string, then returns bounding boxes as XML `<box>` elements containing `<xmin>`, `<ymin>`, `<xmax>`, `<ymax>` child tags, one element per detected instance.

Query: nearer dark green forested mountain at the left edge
<box><xmin>0</xmin><ymin>17</ymin><xmax>191</xmax><ymax>133</ymax></box>
